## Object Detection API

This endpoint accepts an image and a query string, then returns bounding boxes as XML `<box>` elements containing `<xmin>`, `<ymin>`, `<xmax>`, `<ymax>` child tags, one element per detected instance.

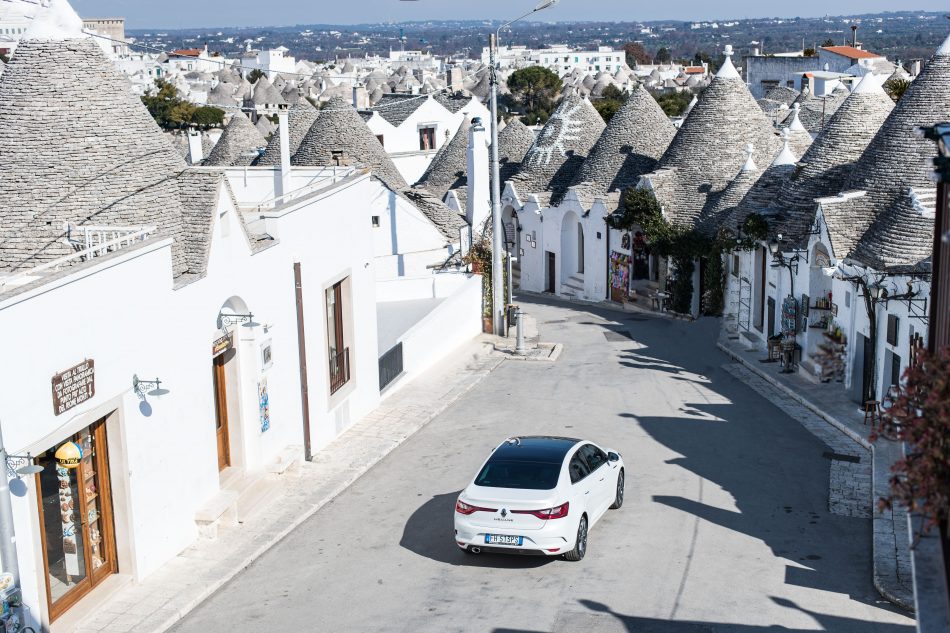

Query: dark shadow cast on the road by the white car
<box><xmin>399</xmin><ymin>491</ymin><xmax>556</xmax><ymax>569</ymax></box>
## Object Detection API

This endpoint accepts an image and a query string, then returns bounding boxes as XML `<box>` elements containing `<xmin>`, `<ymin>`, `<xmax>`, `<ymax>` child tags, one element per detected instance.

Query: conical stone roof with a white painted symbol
<box><xmin>516</xmin><ymin>95</ymin><xmax>606</xmax><ymax>194</ymax></box>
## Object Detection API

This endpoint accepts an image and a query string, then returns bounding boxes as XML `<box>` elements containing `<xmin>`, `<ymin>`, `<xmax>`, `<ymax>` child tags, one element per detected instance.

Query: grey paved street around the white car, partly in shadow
<box><xmin>174</xmin><ymin>301</ymin><xmax>913</xmax><ymax>633</ymax></box>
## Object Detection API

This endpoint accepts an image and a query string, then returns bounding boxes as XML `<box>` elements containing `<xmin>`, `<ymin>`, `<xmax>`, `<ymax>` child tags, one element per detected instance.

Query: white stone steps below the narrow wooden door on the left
<box><xmin>195</xmin><ymin>447</ymin><xmax>301</xmax><ymax>539</ymax></box>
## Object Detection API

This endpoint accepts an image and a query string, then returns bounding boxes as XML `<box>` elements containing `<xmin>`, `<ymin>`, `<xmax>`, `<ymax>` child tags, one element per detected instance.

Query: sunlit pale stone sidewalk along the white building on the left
<box><xmin>74</xmin><ymin>336</ymin><xmax>504</xmax><ymax>633</ymax></box>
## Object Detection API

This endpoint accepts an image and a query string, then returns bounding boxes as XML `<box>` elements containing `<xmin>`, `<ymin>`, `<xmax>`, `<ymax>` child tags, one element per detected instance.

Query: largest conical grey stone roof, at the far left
<box><xmin>0</xmin><ymin>11</ymin><xmax>187</xmax><ymax>275</ymax></box>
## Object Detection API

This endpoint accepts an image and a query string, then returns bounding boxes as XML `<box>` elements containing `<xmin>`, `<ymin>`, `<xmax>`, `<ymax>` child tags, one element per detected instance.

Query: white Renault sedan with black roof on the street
<box><xmin>455</xmin><ymin>436</ymin><xmax>624</xmax><ymax>561</ymax></box>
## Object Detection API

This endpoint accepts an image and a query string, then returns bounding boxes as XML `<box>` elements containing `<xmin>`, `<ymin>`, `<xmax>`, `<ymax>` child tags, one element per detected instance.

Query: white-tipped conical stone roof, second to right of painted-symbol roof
<box><xmin>658</xmin><ymin>57</ymin><xmax>782</xmax><ymax>226</ymax></box>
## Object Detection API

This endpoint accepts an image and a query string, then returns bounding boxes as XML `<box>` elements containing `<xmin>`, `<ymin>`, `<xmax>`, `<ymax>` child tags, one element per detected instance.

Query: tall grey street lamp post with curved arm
<box><xmin>488</xmin><ymin>0</ymin><xmax>558</xmax><ymax>336</ymax></box>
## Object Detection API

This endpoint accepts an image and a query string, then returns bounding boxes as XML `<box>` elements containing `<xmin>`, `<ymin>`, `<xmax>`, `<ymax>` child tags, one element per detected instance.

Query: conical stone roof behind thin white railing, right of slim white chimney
<box><xmin>293</xmin><ymin>96</ymin><xmax>407</xmax><ymax>191</ymax></box>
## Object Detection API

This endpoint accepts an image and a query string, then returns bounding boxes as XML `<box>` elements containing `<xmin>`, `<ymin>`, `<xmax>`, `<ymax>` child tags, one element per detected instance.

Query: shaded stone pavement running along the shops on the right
<box><xmin>718</xmin><ymin>339</ymin><xmax>914</xmax><ymax>611</ymax></box>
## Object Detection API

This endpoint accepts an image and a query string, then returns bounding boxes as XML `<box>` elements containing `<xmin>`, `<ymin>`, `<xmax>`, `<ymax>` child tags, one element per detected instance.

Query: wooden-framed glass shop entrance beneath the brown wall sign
<box><xmin>36</xmin><ymin>418</ymin><xmax>118</xmax><ymax>621</ymax></box>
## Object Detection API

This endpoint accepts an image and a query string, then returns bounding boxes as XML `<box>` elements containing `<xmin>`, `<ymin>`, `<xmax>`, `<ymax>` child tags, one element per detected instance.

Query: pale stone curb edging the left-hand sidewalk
<box><xmin>150</xmin><ymin>348</ymin><xmax>504</xmax><ymax>633</ymax></box>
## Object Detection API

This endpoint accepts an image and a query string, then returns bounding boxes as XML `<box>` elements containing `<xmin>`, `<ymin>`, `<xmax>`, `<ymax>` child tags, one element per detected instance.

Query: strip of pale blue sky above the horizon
<box><xmin>72</xmin><ymin>0</ymin><xmax>946</xmax><ymax>29</ymax></box>
